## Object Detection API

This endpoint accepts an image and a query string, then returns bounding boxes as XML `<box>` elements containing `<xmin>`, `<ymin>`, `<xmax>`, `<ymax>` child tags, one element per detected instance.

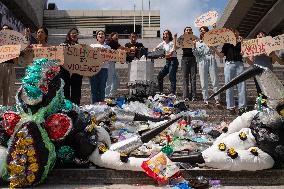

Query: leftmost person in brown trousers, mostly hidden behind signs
<box><xmin>0</xmin><ymin>25</ymin><xmax>17</xmax><ymax>106</ymax></box>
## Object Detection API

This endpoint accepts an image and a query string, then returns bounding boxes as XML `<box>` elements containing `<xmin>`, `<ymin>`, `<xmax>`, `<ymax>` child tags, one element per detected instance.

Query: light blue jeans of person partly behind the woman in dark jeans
<box><xmin>105</xmin><ymin>62</ymin><xmax>119</xmax><ymax>97</ymax></box>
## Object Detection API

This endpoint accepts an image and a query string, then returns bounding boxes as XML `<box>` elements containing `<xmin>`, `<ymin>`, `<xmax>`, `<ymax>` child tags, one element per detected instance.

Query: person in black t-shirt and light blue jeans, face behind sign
<box><xmin>216</xmin><ymin>29</ymin><xmax>247</xmax><ymax>115</ymax></box>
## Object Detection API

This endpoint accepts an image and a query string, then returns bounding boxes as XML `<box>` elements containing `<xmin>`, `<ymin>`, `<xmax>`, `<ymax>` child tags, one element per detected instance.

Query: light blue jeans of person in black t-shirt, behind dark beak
<box><xmin>224</xmin><ymin>61</ymin><xmax>247</xmax><ymax>109</ymax></box>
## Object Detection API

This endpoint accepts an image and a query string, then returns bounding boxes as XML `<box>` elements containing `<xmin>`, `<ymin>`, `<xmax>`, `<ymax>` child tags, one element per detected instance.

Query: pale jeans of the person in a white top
<box><xmin>198</xmin><ymin>55</ymin><xmax>220</xmax><ymax>101</ymax></box>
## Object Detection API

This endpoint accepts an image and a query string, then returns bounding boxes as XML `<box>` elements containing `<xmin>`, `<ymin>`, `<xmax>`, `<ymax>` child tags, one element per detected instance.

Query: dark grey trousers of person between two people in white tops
<box><xmin>181</xmin><ymin>56</ymin><xmax>197</xmax><ymax>99</ymax></box>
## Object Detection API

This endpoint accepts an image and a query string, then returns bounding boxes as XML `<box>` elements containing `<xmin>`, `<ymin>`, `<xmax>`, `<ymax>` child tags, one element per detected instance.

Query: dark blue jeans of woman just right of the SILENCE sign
<box><xmin>90</xmin><ymin>68</ymin><xmax>108</xmax><ymax>103</ymax></box>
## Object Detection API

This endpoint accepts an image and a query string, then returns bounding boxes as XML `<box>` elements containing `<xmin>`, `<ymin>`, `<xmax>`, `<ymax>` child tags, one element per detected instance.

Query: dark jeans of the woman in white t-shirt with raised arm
<box><xmin>157</xmin><ymin>57</ymin><xmax>178</xmax><ymax>94</ymax></box>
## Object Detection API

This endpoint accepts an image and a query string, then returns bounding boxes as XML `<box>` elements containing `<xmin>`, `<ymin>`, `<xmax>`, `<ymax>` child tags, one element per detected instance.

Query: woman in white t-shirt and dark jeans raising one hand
<box><xmin>154</xmin><ymin>30</ymin><xmax>179</xmax><ymax>95</ymax></box>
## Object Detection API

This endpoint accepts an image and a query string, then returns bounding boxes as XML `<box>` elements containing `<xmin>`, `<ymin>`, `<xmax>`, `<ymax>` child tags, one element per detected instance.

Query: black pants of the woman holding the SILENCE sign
<box><xmin>60</xmin><ymin>66</ymin><xmax>83</xmax><ymax>105</ymax></box>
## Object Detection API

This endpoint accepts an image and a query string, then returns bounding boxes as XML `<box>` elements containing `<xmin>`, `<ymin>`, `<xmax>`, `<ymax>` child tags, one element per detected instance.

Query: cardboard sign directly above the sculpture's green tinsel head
<box><xmin>20</xmin><ymin>46</ymin><xmax>64</xmax><ymax>67</ymax></box>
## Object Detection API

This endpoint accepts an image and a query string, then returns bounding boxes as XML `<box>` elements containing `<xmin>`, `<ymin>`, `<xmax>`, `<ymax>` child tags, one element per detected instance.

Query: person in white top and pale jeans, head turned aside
<box><xmin>192</xmin><ymin>26</ymin><xmax>220</xmax><ymax>106</ymax></box>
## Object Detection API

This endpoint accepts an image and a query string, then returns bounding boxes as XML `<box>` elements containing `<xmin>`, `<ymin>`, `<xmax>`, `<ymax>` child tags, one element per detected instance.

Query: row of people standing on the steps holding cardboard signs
<box><xmin>0</xmin><ymin>25</ymin><xmax>282</xmax><ymax>114</ymax></box>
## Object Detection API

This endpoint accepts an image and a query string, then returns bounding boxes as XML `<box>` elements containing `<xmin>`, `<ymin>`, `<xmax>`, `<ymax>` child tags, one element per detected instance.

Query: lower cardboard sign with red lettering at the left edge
<box><xmin>0</xmin><ymin>45</ymin><xmax>21</xmax><ymax>63</ymax></box>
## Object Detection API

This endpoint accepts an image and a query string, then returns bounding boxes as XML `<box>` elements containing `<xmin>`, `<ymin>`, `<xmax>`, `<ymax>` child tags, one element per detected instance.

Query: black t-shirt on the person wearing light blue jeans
<box><xmin>221</xmin><ymin>42</ymin><xmax>243</xmax><ymax>61</ymax></box>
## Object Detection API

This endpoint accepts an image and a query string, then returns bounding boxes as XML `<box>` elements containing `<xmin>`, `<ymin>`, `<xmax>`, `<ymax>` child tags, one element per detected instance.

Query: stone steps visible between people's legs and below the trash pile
<box><xmin>2</xmin><ymin>63</ymin><xmax>284</xmax><ymax>188</ymax></box>
